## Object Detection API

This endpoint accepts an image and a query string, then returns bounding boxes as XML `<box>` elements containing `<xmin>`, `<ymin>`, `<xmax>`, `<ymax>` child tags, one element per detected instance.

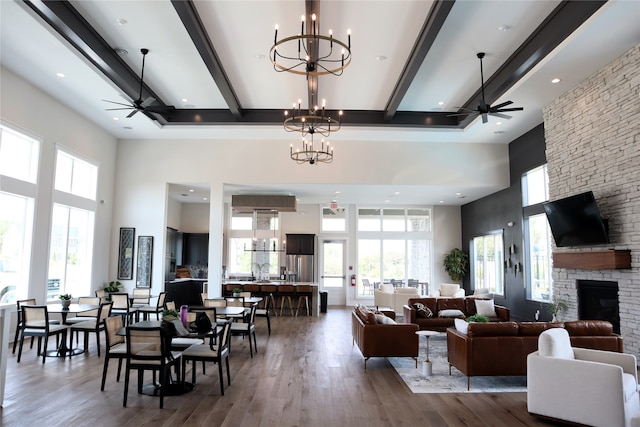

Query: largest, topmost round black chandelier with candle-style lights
<box><xmin>269</xmin><ymin>13</ymin><xmax>351</xmax><ymax>77</ymax></box>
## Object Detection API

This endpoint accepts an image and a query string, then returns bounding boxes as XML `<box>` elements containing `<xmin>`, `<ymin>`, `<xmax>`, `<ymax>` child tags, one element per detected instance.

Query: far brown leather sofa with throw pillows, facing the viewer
<box><xmin>403</xmin><ymin>297</ymin><xmax>510</xmax><ymax>332</ymax></box>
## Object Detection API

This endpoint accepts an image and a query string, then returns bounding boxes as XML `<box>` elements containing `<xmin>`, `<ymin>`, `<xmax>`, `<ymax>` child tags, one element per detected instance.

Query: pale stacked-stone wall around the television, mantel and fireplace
<box><xmin>543</xmin><ymin>45</ymin><xmax>640</xmax><ymax>356</ymax></box>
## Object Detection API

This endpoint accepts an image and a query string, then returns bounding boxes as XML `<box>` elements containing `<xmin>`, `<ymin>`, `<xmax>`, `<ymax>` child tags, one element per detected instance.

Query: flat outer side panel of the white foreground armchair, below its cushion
<box><xmin>527</xmin><ymin>351</ymin><xmax>637</xmax><ymax>426</ymax></box>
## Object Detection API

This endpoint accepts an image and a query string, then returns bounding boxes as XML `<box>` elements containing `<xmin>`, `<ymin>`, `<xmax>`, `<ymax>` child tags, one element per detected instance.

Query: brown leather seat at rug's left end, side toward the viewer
<box><xmin>351</xmin><ymin>306</ymin><xmax>418</xmax><ymax>369</ymax></box>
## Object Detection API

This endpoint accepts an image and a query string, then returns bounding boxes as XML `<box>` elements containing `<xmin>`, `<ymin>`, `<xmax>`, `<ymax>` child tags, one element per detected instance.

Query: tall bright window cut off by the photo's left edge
<box><xmin>0</xmin><ymin>125</ymin><xmax>40</xmax><ymax>303</ymax></box>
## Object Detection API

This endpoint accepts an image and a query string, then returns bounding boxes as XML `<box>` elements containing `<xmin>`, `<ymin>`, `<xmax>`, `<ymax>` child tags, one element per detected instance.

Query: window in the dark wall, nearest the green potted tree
<box><xmin>471</xmin><ymin>230</ymin><xmax>504</xmax><ymax>295</ymax></box>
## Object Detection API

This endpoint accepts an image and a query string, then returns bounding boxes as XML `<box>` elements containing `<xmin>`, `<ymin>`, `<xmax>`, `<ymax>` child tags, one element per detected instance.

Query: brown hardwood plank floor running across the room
<box><xmin>0</xmin><ymin>307</ymin><xmax>554</xmax><ymax>427</ymax></box>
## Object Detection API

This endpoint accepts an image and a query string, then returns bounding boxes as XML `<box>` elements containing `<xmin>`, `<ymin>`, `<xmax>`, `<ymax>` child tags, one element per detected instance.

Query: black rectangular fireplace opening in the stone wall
<box><xmin>577</xmin><ymin>280</ymin><xmax>620</xmax><ymax>334</ymax></box>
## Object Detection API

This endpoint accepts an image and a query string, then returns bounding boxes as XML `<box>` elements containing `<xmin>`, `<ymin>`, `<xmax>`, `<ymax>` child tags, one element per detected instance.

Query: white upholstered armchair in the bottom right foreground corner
<box><xmin>527</xmin><ymin>328</ymin><xmax>640</xmax><ymax>427</ymax></box>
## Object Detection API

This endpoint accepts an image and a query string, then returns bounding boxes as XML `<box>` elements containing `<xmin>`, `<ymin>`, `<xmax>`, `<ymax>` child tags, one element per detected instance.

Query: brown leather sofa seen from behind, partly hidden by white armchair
<box><xmin>447</xmin><ymin>320</ymin><xmax>623</xmax><ymax>388</ymax></box>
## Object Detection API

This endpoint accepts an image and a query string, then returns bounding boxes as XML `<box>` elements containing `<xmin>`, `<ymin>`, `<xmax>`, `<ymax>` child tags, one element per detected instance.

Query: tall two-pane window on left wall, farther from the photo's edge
<box><xmin>47</xmin><ymin>149</ymin><xmax>98</xmax><ymax>299</ymax></box>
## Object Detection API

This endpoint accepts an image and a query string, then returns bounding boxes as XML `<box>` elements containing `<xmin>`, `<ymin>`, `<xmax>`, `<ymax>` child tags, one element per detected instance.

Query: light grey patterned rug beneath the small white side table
<box><xmin>388</xmin><ymin>334</ymin><xmax>527</xmax><ymax>393</ymax></box>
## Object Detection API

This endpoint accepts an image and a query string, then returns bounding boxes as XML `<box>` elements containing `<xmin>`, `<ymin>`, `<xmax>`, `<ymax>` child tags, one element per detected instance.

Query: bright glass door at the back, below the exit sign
<box><xmin>319</xmin><ymin>240</ymin><xmax>347</xmax><ymax>306</ymax></box>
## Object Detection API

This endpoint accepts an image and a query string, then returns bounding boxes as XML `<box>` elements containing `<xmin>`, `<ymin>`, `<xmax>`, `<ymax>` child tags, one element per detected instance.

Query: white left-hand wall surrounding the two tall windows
<box><xmin>0</xmin><ymin>68</ymin><xmax>117</xmax><ymax>303</ymax></box>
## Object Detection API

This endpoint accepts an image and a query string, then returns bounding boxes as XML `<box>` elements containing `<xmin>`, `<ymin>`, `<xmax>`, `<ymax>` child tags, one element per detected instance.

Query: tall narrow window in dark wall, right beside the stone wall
<box><xmin>522</xmin><ymin>165</ymin><xmax>553</xmax><ymax>302</ymax></box>
